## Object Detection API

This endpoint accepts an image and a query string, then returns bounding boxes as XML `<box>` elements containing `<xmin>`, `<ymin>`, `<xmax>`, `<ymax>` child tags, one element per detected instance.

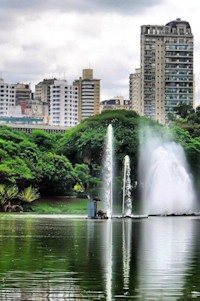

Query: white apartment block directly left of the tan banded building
<box><xmin>49</xmin><ymin>80</ymin><xmax>78</xmax><ymax>127</ymax></box>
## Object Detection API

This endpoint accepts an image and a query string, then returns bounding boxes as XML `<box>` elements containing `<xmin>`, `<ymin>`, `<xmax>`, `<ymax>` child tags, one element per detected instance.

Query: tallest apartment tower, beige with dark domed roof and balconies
<box><xmin>141</xmin><ymin>18</ymin><xmax>194</xmax><ymax>123</ymax></box>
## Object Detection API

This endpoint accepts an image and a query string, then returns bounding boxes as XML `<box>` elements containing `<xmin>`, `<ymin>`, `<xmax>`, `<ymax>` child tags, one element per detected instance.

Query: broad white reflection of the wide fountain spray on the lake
<box><xmin>138</xmin><ymin>217</ymin><xmax>194</xmax><ymax>300</ymax></box>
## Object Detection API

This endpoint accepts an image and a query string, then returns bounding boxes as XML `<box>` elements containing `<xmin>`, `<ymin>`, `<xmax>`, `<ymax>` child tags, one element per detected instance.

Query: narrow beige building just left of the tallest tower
<box><xmin>129</xmin><ymin>68</ymin><xmax>142</xmax><ymax>115</ymax></box>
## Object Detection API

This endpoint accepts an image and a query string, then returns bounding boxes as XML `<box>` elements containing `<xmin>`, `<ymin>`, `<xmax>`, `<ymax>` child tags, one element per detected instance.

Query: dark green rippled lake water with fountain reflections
<box><xmin>0</xmin><ymin>214</ymin><xmax>200</xmax><ymax>301</ymax></box>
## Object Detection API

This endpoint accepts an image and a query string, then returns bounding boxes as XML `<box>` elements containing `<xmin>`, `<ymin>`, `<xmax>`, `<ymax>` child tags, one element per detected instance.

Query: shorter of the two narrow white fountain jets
<box><xmin>122</xmin><ymin>155</ymin><xmax>132</xmax><ymax>217</ymax></box>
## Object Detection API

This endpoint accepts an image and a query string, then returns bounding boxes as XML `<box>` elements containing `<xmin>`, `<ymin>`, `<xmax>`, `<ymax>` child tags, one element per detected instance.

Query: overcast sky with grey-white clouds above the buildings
<box><xmin>0</xmin><ymin>0</ymin><xmax>200</xmax><ymax>104</ymax></box>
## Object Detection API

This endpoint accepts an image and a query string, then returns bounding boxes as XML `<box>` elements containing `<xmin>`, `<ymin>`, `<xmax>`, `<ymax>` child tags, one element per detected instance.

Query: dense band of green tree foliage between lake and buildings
<box><xmin>0</xmin><ymin>107</ymin><xmax>200</xmax><ymax>195</ymax></box>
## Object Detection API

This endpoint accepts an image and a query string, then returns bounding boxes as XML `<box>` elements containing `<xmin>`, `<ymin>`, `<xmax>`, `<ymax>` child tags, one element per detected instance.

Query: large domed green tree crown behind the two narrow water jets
<box><xmin>57</xmin><ymin>110</ymin><xmax>139</xmax><ymax>169</ymax></box>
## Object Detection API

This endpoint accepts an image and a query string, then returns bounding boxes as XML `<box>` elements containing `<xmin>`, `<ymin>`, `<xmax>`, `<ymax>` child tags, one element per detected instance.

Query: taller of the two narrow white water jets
<box><xmin>102</xmin><ymin>124</ymin><xmax>114</xmax><ymax>218</ymax></box>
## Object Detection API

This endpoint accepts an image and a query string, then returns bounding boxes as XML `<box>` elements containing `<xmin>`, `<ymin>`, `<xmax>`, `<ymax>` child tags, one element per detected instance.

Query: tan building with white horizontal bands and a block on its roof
<box><xmin>73</xmin><ymin>69</ymin><xmax>100</xmax><ymax>122</ymax></box>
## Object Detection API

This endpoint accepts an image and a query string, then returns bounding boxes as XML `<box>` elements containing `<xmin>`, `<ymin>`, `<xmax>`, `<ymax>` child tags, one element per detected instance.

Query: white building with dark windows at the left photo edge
<box><xmin>0</xmin><ymin>79</ymin><xmax>16</xmax><ymax>116</ymax></box>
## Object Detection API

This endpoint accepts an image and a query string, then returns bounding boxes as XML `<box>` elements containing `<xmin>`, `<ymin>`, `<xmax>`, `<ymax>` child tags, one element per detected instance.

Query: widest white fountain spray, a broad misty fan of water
<box><xmin>140</xmin><ymin>125</ymin><xmax>195</xmax><ymax>215</ymax></box>
